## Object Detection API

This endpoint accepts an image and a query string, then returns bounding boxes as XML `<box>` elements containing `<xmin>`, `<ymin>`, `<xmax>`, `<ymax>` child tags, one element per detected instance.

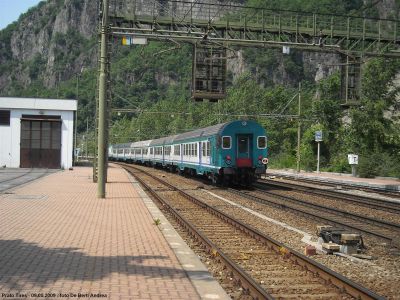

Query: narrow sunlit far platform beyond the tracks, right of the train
<box><xmin>266</xmin><ymin>169</ymin><xmax>400</xmax><ymax>192</ymax></box>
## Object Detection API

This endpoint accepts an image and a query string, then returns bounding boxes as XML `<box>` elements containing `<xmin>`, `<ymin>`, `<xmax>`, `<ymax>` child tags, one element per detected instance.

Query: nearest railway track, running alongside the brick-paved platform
<box><xmin>123</xmin><ymin>165</ymin><xmax>381</xmax><ymax>299</ymax></box>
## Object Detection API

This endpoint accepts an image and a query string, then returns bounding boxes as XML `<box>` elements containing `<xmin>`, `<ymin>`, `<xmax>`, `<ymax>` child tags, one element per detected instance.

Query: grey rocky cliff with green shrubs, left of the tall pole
<box><xmin>0</xmin><ymin>0</ymin><xmax>98</xmax><ymax>92</ymax></box>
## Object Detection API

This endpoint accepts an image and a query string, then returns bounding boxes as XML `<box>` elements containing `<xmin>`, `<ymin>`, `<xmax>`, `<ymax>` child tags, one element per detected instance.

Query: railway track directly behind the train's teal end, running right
<box><xmin>229</xmin><ymin>189</ymin><xmax>400</xmax><ymax>242</ymax></box>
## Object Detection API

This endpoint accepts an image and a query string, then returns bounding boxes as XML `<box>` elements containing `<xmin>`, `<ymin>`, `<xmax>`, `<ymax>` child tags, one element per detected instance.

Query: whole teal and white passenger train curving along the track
<box><xmin>108</xmin><ymin>120</ymin><xmax>268</xmax><ymax>185</ymax></box>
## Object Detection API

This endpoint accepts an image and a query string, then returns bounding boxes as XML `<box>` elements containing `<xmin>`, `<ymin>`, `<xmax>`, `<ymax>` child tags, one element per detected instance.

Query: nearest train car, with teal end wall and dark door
<box><xmin>174</xmin><ymin>121</ymin><xmax>268</xmax><ymax>185</ymax></box>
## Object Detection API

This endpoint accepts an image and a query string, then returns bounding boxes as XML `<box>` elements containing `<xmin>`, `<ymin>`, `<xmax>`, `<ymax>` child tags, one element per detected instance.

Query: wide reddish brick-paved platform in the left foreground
<box><xmin>0</xmin><ymin>166</ymin><xmax>229</xmax><ymax>300</ymax></box>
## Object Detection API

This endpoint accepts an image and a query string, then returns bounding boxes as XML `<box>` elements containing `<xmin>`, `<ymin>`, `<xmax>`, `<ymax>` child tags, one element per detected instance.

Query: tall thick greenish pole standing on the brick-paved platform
<box><xmin>97</xmin><ymin>0</ymin><xmax>108</xmax><ymax>198</ymax></box>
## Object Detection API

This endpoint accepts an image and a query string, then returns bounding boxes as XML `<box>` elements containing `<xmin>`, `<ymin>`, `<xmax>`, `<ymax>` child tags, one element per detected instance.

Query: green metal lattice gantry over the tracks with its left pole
<box><xmin>98</xmin><ymin>0</ymin><xmax>400</xmax><ymax>197</ymax></box>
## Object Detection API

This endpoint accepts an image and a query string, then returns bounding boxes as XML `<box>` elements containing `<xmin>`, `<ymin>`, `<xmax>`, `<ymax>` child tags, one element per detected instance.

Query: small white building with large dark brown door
<box><xmin>0</xmin><ymin>97</ymin><xmax>78</xmax><ymax>169</ymax></box>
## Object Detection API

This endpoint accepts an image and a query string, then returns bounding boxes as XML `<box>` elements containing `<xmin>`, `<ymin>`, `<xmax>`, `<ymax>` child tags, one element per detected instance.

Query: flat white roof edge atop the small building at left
<box><xmin>0</xmin><ymin>97</ymin><xmax>78</xmax><ymax>111</ymax></box>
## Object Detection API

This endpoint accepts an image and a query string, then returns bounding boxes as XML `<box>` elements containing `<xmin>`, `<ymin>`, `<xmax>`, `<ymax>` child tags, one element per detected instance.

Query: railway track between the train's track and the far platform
<box><xmin>254</xmin><ymin>179</ymin><xmax>400</xmax><ymax>214</ymax></box>
